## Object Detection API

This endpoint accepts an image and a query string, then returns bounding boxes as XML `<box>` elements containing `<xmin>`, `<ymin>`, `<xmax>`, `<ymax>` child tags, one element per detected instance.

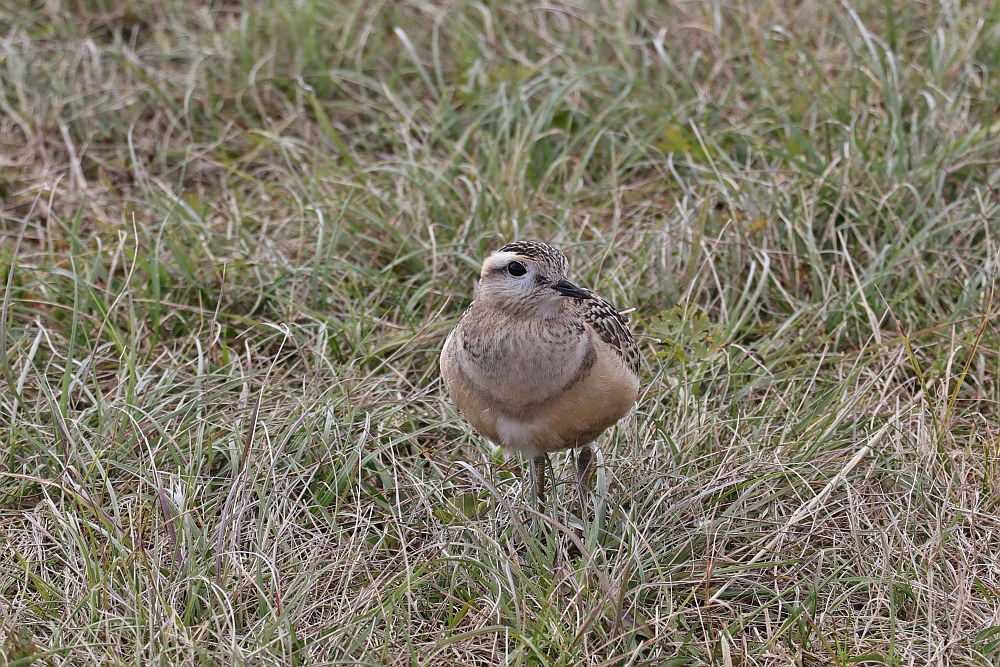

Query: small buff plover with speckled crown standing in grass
<box><xmin>440</xmin><ymin>240</ymin><xmax>640</xmax><ymax>504</ymax></box>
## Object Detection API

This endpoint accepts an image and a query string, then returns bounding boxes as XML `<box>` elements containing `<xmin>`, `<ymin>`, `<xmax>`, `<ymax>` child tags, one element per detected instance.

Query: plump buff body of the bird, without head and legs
<box><xmin>441</xmin><ymin>293</ymin><xmax>639</xmax><ymax>456</ymax></box>
